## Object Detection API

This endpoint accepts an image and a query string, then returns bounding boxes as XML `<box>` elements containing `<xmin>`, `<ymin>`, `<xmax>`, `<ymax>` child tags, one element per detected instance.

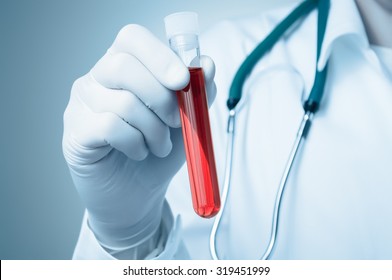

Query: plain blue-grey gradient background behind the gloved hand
<box><xmin>0</xmin><ymin>0</ymin><xmax>293</xmax><ymax>259</ymax></box>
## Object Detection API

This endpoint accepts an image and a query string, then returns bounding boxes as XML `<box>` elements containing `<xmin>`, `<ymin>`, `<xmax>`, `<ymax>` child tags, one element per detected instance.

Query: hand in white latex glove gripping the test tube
<box><xmin>63</xmin><ymin>25</ymin><xmax>216</xmax><ymax>258</ymax></box>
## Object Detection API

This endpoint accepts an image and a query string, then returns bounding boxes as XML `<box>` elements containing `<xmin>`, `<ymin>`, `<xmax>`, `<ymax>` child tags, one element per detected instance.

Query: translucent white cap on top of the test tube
<box><xmin>164</xmin><ymin>12</ymin><xmax>199</xmax><ymax>39</ymax></box>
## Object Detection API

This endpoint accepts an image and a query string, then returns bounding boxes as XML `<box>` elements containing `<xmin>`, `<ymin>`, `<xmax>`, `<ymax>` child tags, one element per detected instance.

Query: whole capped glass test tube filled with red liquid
<box><xmin>164</xmin><ymin>12</ymin><xmax>220</xmax><ymax>218</ymax></box>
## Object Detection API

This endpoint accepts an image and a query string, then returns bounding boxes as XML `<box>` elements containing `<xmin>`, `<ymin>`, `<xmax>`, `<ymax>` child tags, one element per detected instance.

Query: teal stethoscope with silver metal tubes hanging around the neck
<box><xmin>210</xmin><ymin>0</ymin><xmax>330</xmax><ymax>260</ymax></box>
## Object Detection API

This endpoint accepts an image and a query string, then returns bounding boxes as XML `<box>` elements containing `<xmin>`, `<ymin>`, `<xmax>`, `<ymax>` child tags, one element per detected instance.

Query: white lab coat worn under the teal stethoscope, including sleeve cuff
<box><xmin>74</xmin><ymin>0</ymin><xmax>392</xmax><ymax>259</ymax></box>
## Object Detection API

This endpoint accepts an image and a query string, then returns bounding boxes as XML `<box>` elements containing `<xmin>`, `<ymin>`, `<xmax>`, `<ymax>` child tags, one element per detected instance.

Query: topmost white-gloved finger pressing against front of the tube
<box><xmin>109</xmin><ymin>24</ymin><xmax>189</xmax><ymax>90</ymax></box>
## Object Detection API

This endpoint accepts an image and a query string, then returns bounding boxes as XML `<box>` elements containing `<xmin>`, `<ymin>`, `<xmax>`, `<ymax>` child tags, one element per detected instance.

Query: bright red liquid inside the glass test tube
<box><xmin>177</xmin><ymin>67</ymin><xmax>220</xmax><ymax>218</ymax></box>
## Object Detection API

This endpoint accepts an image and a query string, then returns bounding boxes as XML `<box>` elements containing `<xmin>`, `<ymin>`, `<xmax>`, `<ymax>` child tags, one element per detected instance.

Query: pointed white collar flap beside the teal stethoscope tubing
<box><xmin>317</xmin><ymin>0</ymin><xmax>369</xmax><ymax>70</ymax></box>
